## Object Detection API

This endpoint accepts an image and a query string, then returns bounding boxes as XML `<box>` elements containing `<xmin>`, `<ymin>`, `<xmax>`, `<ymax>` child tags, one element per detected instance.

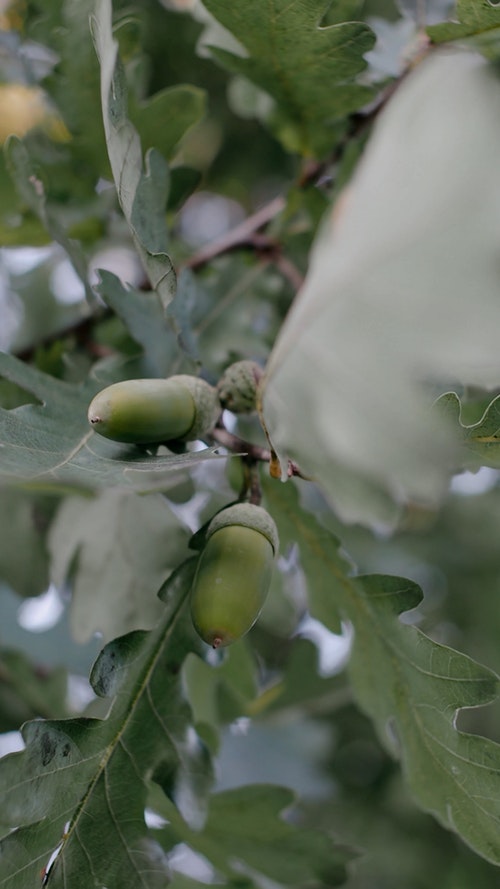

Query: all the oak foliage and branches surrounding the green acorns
<box><xmin>0</xmin><ymin>0</ymin><xmax>500</xmax><ymax>889</ymax></box>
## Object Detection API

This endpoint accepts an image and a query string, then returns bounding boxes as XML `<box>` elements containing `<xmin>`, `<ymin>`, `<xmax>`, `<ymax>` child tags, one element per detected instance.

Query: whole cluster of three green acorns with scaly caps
<box><xmin>88</xmin><ymin>361</ymin><xmax>278</xmax><ymax>648</ymax></box>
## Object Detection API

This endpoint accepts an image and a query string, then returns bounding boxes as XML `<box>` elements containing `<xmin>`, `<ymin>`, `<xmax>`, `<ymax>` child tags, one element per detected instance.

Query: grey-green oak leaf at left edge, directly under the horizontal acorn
<box><xmin>0</xmin><ymin>353</ymin><xmax>221</xmax><ymax>491</ymax></box>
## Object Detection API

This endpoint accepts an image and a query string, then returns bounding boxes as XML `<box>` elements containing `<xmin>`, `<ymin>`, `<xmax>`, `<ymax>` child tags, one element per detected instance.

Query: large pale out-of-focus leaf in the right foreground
<box><xmin>263</xmin><ymin>53</ymin><xmax>500</xmax><ymax>526</ymax></box>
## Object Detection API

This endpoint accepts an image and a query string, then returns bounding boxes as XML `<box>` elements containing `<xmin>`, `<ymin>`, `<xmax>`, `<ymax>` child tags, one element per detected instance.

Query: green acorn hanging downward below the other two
<box><xmin>191</xmin><ymin>503</ymin><xmax>278</xmax><ymax>648</ymax></box>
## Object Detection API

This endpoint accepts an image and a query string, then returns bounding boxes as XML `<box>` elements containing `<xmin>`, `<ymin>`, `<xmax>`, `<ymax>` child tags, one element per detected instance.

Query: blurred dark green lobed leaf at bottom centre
<box><xmin>152</xmin><ymin>784</ymin><xmax>353</xmax><ymax>889</ymax></box>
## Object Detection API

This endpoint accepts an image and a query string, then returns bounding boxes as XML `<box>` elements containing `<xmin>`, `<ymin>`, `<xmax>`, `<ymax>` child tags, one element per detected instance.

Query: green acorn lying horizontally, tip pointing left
<box><xmin>88</xmin><ymin>374</ymin><xmax>220</xmax><ymax>444</ymax></box>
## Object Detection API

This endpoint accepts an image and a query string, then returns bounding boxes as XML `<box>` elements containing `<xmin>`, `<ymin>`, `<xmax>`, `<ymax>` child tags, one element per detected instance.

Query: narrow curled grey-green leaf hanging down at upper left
<box><xmin>92</xmin><ymin>0</ymin><xmax>181</xmax><ymax>307</ymax></box>
